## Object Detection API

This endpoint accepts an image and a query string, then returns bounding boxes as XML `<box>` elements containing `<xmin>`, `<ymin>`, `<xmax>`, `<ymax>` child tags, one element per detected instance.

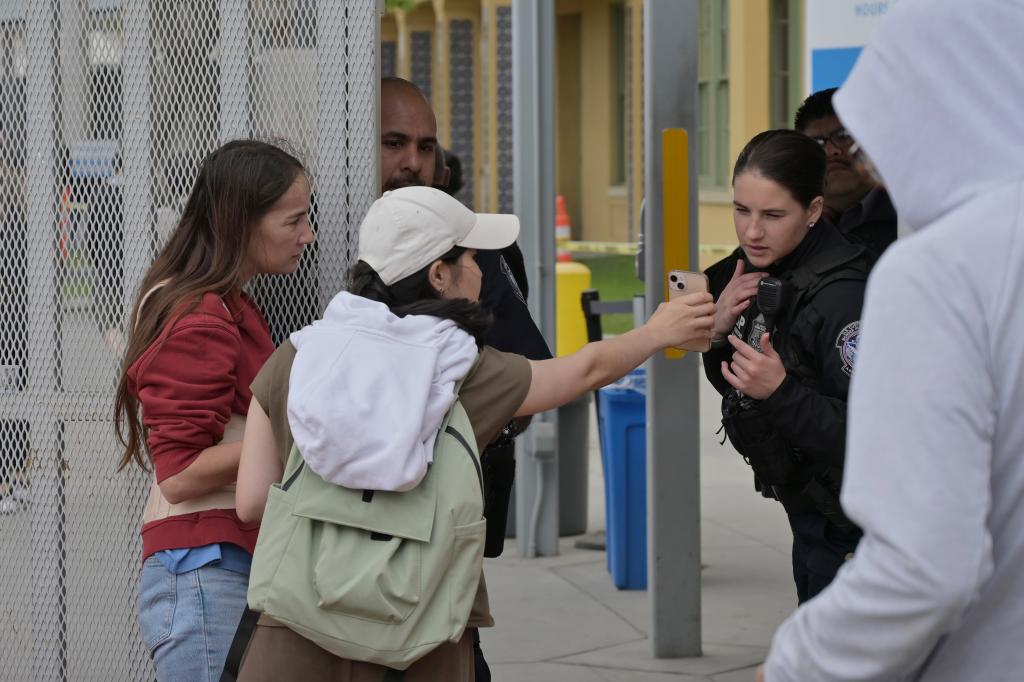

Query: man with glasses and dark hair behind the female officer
<box><xmin>794</xmin><ymin>88</ymin><xmax>896</xmax><ymax>259</ymax></box>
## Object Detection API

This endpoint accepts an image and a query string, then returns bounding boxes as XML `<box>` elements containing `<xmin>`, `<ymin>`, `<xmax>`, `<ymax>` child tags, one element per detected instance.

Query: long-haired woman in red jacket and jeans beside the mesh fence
<box><xmin>115</xmin><ymin>140</ymin><xmax>313</xmax><ymax>682</ymax></box>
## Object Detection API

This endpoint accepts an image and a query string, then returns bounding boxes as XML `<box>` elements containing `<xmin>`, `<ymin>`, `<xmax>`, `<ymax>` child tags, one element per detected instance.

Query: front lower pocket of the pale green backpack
<box><xmin>313</xmin><ymin>522</ymin><xmax>422</xmax><ymax>624</ymax></box>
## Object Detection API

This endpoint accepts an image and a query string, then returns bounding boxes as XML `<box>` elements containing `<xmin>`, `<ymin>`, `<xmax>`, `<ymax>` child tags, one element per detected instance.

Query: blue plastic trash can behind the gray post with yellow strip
<box><xmin>598</xmin><ymin>368</ymin><xmax>647</xmax><ymax>590</ymax></box>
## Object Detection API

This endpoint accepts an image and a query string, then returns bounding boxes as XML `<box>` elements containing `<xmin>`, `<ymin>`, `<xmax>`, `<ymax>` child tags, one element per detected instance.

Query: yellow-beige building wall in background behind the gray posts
<box><xmin>382</xmin><ymin>0</ymin><xmax>771</xmax><ymax>266</ymax></box>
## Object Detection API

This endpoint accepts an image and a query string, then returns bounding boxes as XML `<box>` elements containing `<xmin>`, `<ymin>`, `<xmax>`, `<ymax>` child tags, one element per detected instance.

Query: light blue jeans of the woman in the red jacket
<box><xmin>137</xmin><ymin>556</ymin><xmax>249</xmax><ymax>682</ymax></box>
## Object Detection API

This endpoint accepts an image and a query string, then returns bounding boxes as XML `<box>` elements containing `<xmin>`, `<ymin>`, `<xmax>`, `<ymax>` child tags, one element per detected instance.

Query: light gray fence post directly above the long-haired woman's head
<box><xmin>217</xmin><ymin>0</ymin><xmax>250</xmax><ymax>143</ymax></box>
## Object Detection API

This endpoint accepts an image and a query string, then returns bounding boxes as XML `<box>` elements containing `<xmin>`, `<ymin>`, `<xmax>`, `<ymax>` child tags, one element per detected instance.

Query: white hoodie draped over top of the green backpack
<box><xmin>288</xmin><ymin>292</ymin><xmax>477</xmax><ymax>491</ymax></box>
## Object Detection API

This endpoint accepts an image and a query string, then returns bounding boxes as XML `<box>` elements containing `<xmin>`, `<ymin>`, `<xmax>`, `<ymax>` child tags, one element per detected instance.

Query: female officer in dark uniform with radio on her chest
<box><xmin>703</xmin><ymin>130</ymin><xmax>867</xmax><ymax>602</ymax></box>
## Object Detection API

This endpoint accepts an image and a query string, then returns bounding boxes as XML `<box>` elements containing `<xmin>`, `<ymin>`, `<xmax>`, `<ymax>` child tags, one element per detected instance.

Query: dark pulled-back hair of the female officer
<box><xmin>732</xmin><ymin>130</ymin><xmax>825</xmax><ymax>208</ymax></box>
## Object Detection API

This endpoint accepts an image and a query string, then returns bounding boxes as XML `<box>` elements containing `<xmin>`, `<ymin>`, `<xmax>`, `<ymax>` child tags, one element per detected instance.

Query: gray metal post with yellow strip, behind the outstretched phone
<box><xmin>644</xmin><ymin>0</ymin><xmax>700</xmax><ymax>657</ymax></box>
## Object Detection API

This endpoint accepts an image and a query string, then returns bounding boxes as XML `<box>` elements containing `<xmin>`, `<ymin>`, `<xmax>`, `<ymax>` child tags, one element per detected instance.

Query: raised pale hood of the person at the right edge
<box><xmin>835</xmin><ymin>0</ymin><xmax>1024</xmax><ymax>229</ymax></box>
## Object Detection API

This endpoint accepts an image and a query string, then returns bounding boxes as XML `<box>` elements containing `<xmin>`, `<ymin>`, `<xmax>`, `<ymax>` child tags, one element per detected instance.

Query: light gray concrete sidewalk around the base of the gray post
<box><xmin>481</xmin><ymin>382</ymin><xmax>797</xmax><ymax>682</ymax></box>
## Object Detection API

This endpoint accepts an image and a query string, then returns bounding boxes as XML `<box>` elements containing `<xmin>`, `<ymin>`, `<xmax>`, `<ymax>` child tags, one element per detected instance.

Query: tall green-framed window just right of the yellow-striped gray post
<box><xmin>697</xmin><ymin>0</ymin><xmax>729</xmax><ymax>188</ymax></box>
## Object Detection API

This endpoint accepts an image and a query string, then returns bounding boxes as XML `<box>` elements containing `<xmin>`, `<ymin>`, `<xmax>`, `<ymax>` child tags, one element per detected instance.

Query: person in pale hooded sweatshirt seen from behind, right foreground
<box><xmin>761</xmin><ymin>0</ymin><xmax>1024</xmax><ymax>682</ymax></box>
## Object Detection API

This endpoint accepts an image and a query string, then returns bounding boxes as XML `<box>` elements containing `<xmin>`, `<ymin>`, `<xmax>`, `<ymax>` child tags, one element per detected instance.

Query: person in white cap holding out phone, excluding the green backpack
<box><xmin>237</xmin><ymin>186</ymin><xmax>715</xmax><ymax>681</ymax></box>
